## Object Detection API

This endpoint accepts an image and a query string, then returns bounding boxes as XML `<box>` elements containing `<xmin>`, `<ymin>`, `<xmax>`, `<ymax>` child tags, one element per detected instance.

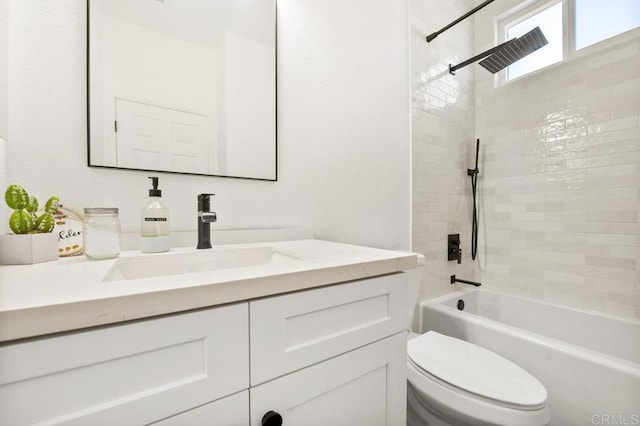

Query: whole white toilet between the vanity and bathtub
<box><xmin>407</xmin><ymin>268</ymin><xmax>550</xmax><ymax>426</ymax></box>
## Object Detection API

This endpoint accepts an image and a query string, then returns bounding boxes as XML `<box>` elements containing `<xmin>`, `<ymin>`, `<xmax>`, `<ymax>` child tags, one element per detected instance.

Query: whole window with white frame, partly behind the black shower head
<box><xmin>498</xmin><ymin>0</ymin><xmax>640</xmax><ymax>81</ymax></box>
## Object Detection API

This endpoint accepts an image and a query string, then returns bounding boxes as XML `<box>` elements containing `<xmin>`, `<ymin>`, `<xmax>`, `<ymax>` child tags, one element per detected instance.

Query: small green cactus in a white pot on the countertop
<box><xmin>0</xmin><ymin>184</ymin><xmax>59</xmax><ymax>265</ymax></box>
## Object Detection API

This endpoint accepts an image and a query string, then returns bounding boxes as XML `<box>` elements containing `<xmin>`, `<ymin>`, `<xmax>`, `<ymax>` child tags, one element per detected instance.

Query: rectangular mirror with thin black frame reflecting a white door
<box><xmin>87</xmin><ymin>0</ymin><xmax>276</xmax><ymax>180</ymax></box>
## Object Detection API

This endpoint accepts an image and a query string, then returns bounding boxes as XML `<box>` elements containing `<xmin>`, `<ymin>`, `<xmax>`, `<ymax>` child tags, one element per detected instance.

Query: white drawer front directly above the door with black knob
<box><xmin>249</xmin><ymin>273</ymin><xmax>408</xmax><ymax>385</ymax></box>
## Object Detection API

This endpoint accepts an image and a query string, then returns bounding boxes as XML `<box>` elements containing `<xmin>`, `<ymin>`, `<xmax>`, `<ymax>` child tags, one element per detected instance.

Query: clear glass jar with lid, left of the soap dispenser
<box><xmin>82</xmin><ymin>207</ymin><xmax>120</xmax><ymax>259</ymax></box>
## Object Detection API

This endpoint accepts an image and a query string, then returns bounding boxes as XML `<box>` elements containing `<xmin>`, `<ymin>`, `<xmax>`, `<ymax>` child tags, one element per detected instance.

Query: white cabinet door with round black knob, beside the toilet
<box><xmin>251</xmin><ymin>332</ymin><xmax>407</xmax><ymax>426</ymax></box>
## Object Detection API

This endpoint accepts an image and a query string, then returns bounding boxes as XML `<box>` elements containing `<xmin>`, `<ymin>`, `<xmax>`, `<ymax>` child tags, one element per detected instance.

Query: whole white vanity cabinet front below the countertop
<box><xmin>0</xmin><ymin>273</ymin><xmax>408</xmax><ymax>426</ymax></box>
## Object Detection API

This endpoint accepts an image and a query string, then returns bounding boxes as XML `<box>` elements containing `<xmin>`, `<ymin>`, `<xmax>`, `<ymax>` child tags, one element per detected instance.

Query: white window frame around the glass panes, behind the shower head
<box><xmin>494</xmin><ymin>0</ymin><xmax>640</xmax><ymax>86</ymax></box>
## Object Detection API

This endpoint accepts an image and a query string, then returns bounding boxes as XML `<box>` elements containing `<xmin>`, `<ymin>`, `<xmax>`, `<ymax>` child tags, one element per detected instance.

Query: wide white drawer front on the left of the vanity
<box><xmin>0</xmin><ymin>303</ymin><xmax>249</xmax><ymax>426</ymax></box>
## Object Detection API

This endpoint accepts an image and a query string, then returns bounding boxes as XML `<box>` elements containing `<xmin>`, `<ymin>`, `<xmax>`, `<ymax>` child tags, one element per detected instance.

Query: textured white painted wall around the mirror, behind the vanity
<box><xmin>3</xmin><ymin>0</ymin><xmax>410</xmax><ymax>249</ymax></box>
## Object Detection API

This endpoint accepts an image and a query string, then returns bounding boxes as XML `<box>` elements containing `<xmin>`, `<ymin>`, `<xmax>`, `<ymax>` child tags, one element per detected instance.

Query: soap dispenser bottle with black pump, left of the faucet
<box><xmin>140</xmin><ymin>176</ymin><xmax>169</xmax><ymax>253</ymax></box>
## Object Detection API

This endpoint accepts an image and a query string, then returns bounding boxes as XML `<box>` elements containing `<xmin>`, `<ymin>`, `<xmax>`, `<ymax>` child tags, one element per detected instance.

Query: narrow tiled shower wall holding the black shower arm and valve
<box><xmin>411</xmin><ymin>0</ymin><xmax>475</xmax><ymax>327</ymax></box>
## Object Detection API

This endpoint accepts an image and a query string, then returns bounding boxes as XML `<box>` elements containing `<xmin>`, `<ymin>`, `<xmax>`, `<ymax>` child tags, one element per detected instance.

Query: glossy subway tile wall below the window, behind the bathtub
<box><xmin>478</xmin><ymin>31</ymin><xmax>640</xmax><ymax>318</ymax></box>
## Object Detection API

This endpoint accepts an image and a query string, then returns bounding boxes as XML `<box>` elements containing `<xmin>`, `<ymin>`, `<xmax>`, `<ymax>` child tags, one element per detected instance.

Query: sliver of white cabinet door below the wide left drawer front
<box><xmin>153</xmin><ymin>390</ymin><xmax>249</xmax><ymax>426</ymax></box>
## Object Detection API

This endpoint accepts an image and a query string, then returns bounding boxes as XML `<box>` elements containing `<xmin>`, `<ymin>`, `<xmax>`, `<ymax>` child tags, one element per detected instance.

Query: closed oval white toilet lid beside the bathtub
<box><xmin>407</xmin><ymin>331</ymin><xmax>547</xmax><ymax>409</ymax></box>
